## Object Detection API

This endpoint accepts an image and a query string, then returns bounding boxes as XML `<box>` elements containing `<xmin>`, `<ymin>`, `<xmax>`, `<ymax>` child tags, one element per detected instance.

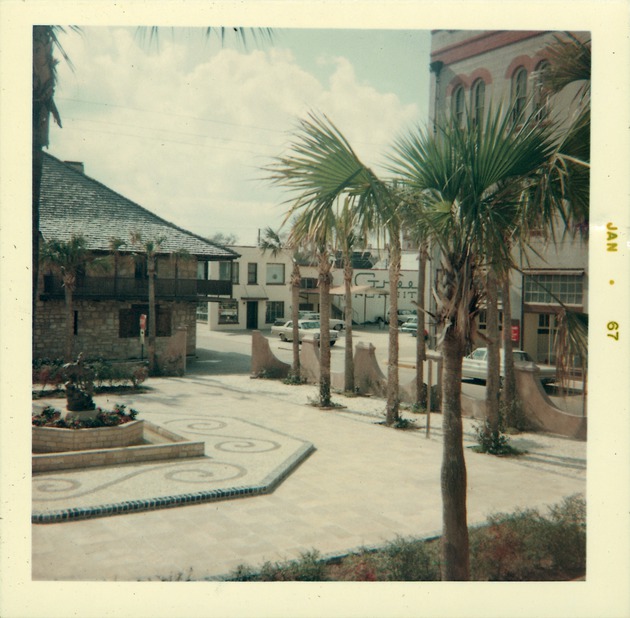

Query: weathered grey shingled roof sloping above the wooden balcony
<box><xmin>39</xmin><ymin>153</ymin><xmax>239</xmax><ymax>260</ymax></box>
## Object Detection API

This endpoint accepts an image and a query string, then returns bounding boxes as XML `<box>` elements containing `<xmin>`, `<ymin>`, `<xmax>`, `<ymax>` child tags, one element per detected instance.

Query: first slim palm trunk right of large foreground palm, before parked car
<box><xmin>486</xmin><ymin>268</ymin><xmax>501</xmax><ymax>433</ymax></box>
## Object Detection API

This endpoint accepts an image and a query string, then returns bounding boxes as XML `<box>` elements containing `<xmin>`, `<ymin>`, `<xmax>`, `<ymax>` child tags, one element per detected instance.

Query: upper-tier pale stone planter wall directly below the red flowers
<box><xmin>33</xmin><ymin>421</ymin><xmax>144</xmax><ymax>453</ymax></box>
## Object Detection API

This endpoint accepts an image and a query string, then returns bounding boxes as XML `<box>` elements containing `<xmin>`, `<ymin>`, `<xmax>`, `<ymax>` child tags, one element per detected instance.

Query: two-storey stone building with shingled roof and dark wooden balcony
<box><xmin>33</xmin><ymin>154</ymin><xmax>238</xmax><ymax>360</ymax></box>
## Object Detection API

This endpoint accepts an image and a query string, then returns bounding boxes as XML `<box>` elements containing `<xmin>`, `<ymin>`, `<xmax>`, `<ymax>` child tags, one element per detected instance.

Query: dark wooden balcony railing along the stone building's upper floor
<box><xmin>42</xmin><ymin>275</ymin><xmax>232</xmax><ymax>301</ymax></box>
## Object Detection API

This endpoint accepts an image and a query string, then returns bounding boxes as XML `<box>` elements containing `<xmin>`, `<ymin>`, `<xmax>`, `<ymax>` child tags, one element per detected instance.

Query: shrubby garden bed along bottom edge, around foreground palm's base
<box><xmin>226</xmin><ymin>495</ymin><xmax>586</xmax><ymax>581</ymax></box>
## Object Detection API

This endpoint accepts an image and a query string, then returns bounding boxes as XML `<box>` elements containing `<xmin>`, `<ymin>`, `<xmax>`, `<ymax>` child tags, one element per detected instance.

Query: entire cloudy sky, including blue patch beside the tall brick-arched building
<box><xmin>48</xmin><ymin>26</ymin><xmax>430</xmax><ymax>245</ymax></box>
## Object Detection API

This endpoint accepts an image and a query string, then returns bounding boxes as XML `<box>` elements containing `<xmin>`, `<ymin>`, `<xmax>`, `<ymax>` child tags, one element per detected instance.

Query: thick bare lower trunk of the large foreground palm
<box><xmin>441</xmin><ymin>326</ymin><xmax>470</xmax><ymax>581</ymax></box>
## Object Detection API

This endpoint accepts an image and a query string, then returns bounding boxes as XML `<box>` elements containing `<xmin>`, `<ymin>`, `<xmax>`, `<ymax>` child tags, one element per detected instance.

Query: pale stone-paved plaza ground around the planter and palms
<box><xmin>32</xmin><ymin>375</ymin><xmax>586</xmax><ymax>581</ymax></box>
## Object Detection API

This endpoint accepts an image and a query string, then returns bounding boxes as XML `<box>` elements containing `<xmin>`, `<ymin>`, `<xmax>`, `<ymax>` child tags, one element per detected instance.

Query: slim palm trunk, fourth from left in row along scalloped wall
<box><xmin>385</xmin><ymin>229</ymin><xmax>400</xmax><ymax>425</ymax></box>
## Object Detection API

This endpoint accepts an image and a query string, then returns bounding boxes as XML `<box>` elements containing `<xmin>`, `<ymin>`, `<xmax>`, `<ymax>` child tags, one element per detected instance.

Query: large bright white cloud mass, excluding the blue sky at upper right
<box><xmin>50</xmin><ymin>28</ymin><xmax>418</xmax><ymax>243</ymax></box>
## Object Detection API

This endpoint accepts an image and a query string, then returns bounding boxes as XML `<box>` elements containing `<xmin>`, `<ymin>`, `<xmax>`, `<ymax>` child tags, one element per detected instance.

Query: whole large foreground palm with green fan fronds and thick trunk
<box><xmin>392</xmin><ymin>102</ymin><xmax>553</xmax><ymax>579</ymax></box>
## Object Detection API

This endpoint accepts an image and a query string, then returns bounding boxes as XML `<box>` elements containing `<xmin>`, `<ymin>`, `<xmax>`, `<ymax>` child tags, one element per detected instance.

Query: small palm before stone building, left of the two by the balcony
<box><xmin>41</xmin><ymin>236</ymin><xmax>104</xmax><ymax>363</ymax></box>
